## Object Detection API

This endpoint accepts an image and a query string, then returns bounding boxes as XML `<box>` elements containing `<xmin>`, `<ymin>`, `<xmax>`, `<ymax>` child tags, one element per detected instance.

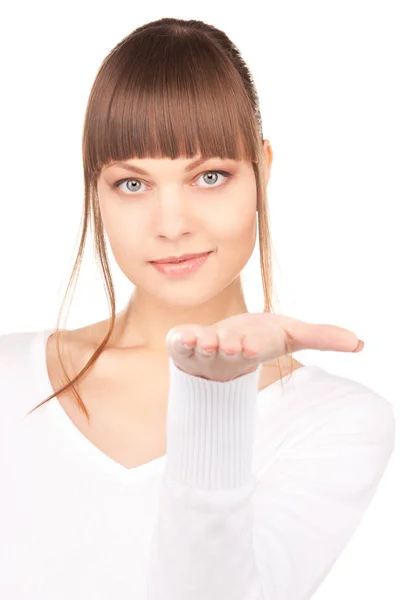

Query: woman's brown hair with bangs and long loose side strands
<box><xmin>27</xmin><ymin>18</ymin><xmax>293</xmax><ymax>421</ymax></box>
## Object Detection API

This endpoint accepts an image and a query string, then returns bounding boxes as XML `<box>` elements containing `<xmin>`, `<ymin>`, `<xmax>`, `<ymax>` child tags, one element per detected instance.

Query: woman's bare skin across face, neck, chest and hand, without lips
<box><xmin>46</xmin><ymin>140</ymin><xmax>364</xmax><ymax>468</ymax></box>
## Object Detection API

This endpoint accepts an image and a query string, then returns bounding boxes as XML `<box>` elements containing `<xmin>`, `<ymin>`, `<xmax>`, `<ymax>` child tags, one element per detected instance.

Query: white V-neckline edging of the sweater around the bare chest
<box><xmin>32</xmin><ymin>328</ymin><xmax>319</xmax><ymax>483</ymax></box>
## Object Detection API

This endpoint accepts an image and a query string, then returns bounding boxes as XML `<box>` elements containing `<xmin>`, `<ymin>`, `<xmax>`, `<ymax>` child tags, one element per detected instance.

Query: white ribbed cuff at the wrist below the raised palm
<box><xmin>165</xmin><ymin>358</ymin><xmax>260</xmax><ymax>489</ymax></box>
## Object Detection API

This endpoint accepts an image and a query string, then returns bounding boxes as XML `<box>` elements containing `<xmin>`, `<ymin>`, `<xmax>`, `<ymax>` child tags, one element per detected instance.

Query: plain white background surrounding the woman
<box><xmin>0</xmin><ymin>0</ymin><xmax>408</xmax><ymax>600</ymax></box>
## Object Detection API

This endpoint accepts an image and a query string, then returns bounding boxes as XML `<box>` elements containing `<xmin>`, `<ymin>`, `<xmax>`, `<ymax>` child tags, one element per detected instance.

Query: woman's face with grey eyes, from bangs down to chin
<box><xmin>98</xmin><ymin>140</ymin><xmax>272</xmax><ymax>308</ymax></box>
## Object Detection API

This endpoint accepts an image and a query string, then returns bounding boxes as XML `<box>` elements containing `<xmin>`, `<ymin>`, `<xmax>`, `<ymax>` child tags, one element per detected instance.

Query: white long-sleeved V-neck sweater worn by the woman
<box><xmin>0</xmin><ymin>329</ymin><xmax>395</xmax><ymax>600</ymax></box>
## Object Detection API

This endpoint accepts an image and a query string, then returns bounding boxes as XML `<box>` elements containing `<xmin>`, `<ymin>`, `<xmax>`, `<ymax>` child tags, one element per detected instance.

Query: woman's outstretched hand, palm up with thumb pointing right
<box><xmin>166</xmin><ymin>313</ymin><xmax>364</xmax><ymax>381</ymax></box>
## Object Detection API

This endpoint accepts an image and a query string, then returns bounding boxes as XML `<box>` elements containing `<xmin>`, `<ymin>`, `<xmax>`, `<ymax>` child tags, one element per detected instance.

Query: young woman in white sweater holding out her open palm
<box><xmin>0</xmin><ymin>18</ymin><xmax>395</xmax><ymax>600</ymax></box>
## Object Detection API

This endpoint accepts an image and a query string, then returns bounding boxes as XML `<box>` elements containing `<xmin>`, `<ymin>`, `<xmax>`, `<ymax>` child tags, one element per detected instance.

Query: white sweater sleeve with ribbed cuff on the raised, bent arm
<box><xmin>147</xmin><ymin>360</ymin><xmax>395</xmax><ymax>600</ymax></box>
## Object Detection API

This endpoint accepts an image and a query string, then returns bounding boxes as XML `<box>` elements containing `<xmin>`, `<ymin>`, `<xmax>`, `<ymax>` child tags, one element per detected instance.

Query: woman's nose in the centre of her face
<box><xmin>153</xmin><ymin>190</ymin><xmax>191</xmax><ymax>240</ymax></box>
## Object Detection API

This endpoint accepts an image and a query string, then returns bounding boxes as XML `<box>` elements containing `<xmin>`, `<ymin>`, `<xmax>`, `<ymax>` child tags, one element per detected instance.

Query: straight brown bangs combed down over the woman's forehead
<box><xmin>82</xmin><ymin>28</ymin><xmax>262</xmax><ymax>185</ymax></box>
